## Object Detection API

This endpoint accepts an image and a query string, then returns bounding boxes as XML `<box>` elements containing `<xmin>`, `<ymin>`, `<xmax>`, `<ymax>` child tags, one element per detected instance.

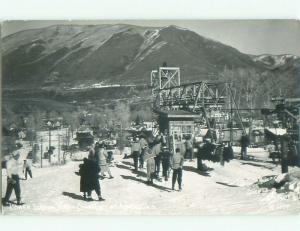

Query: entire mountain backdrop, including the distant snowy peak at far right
<box><xmin>2</xmin><ymin>24</ymin><xmax>300</xmax><ymax>103</ymax></box>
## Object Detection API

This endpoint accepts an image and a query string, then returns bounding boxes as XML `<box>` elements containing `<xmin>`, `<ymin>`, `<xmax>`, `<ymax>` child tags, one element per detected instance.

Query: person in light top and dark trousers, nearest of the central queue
<box><xmin>171</xmin><ymin>148</ymin><xmax>184</xmax><ymax>191</ymax></box>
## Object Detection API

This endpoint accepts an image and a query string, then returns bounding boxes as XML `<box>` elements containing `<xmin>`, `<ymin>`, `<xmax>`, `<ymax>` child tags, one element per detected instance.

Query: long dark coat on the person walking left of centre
<box><xmin>79</xmin><ymin>158</ymin><xmax>100</xmax><ymax>192</ymax></box>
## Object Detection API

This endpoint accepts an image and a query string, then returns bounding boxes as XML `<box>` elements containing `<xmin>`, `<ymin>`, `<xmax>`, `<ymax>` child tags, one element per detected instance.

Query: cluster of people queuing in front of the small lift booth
<box><xmin>129</xmin><ymin>134</ymin><xmax>184</xmax><ymax>190</ymax></box>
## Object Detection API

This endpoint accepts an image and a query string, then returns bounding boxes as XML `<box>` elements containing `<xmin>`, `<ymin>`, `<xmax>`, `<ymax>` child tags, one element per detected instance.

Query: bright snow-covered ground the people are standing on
<box><xmin>2</xmin><ymin>149</ymin><xmax>300</xmax><ymax>215</ymax></box>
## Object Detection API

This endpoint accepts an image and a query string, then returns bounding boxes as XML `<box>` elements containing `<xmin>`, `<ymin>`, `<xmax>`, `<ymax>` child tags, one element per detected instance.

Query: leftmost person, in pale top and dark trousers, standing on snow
<box><xmin>3</xmin><ymin>152</ymin><xmax>23</xmax><ymax>206</ymax></box>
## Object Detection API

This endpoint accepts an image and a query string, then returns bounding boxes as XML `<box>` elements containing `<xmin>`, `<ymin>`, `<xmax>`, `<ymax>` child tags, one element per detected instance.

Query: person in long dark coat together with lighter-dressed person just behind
<box><xmin>78</xmin><ymin>142</ymin><xmax>113</xmax><ymax>201</ymax></box>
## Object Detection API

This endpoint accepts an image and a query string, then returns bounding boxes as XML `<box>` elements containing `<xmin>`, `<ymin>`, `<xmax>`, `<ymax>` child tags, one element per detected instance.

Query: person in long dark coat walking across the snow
<box><xmin>79</xmin><ymin>155</ymin><xmax>104</xmax><ymax>201</ymax></box>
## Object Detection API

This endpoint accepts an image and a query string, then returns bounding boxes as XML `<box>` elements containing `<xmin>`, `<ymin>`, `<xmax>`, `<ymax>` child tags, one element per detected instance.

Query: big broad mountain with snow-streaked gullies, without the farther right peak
<box><xmin>2</xmin><ymin>24</ymin><xmax>265</xmax><ymax>88</ymax></box>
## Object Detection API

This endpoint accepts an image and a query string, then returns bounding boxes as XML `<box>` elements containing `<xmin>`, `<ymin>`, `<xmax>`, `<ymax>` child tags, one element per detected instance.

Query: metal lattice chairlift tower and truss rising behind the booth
<box><xmin>151</xmin><ymin>67</ymin><xmax>245</xmax><ymax>145</ymax></box>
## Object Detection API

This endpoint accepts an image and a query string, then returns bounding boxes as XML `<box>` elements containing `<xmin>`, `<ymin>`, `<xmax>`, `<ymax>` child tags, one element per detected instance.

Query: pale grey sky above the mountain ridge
<box><xmin>2</xmin><ymin>20</ymin><xmax>300</xmax><ymax>56</ymax></box>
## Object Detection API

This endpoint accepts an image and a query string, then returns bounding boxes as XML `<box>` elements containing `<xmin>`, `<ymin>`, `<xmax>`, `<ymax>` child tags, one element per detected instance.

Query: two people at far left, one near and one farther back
<box><xmin>2</xmin><ymin>151</ymin><xmax>32</xmax><ymax>206</ymax></box>
